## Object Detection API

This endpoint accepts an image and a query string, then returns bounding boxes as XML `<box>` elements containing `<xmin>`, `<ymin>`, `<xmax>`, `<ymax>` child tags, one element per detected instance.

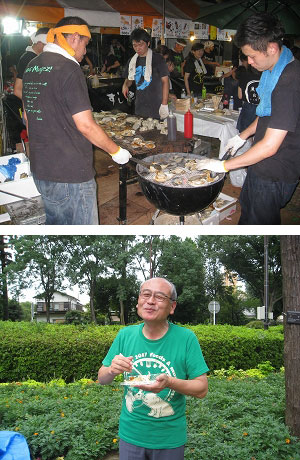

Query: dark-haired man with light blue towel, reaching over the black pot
<box><xmin>200</xmin><ymin>13</ymin><xmax>300</xmax><ymax>225</ymax></box>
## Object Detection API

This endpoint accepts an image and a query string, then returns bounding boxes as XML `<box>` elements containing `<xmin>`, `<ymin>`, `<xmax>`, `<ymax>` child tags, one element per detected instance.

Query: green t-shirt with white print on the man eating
<box><xmin>103</xmin><ymin>323</ymin><xmax>209</xmax><ymax>449</ymax></box>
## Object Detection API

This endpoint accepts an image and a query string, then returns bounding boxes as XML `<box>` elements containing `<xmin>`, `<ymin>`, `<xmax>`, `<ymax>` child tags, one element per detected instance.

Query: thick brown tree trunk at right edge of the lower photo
<box><xmin>281</xmin><ymin>235</ymin><xmax>300</xmax><ymax>437</ymax></box>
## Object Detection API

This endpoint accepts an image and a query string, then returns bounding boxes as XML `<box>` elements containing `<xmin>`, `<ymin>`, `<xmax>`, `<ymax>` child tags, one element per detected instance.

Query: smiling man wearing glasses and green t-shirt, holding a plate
<box><xmin>98</xmin><ymin>278</ymin><xmax>208</xmax><ymax>460</ymax></box>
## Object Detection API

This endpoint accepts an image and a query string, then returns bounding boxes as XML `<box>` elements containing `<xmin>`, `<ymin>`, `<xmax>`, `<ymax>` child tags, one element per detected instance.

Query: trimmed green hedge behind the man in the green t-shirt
<box><xmin>0</xmin><ymin>321</ymin><xmax>283</xmax><ymax>382</ymax></box>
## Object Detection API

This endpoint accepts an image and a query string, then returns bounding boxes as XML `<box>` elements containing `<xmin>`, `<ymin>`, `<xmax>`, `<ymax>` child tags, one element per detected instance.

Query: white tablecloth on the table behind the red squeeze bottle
<box><xmin>174</xmin><ymin>110</ymin><xmax>238</xmax><ymax>158</ymax></box>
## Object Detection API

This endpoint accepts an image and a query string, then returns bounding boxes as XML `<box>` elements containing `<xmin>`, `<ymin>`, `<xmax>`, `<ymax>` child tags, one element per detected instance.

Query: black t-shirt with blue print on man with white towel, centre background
<box><xmin>124</xmin><ymin>53</ymin><xmax>169</xmax><ymax>118</ymax></box>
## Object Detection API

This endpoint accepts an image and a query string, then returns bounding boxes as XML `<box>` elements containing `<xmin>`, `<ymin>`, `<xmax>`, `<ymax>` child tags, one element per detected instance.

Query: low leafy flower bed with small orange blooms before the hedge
<box><xmin>0</xmin><ymin>372</ymin><xmax>300</xmax><ymax>460</ymax></box>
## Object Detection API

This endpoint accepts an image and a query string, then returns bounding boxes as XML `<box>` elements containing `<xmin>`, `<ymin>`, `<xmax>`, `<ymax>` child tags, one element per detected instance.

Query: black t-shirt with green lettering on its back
<box><xmin>23</xmin><ymin>51</ymin><xmax>95</xmax><ymax>183</ymax></box>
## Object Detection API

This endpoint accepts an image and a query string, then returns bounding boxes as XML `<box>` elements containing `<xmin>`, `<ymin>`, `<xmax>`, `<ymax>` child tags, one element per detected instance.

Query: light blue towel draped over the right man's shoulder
<box><xmin>256</xmin><ymin>46</ymin><xmax>294</xmax><ymax>117</ymax></box>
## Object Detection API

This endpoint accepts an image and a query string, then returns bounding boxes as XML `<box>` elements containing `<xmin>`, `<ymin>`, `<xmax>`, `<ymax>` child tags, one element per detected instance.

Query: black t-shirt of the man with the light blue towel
<box><xmin>249</xmin><ymin>60</ymin><xmax>300</xmax><ymax>183</ymax></box>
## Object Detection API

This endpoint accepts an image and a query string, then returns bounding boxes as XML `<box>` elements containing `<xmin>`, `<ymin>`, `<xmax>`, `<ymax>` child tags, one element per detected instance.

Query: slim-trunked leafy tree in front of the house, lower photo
<box><xmin>7</xmin><ymin>235</ymin><xmax>67</xmax><ymax>322</ymax></box>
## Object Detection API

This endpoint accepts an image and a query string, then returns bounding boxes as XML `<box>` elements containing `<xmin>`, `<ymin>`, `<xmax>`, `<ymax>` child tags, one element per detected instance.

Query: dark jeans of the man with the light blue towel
<box><xmin>239</xmin><ymin>167</ymin><xmax>298</xmax><ymax>225</ymax></box>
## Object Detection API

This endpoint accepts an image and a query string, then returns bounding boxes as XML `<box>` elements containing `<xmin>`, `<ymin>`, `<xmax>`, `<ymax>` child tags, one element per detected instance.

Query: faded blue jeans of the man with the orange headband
<box><xmin>33</xmin><ymin>176</ymin><xmax>99</xmax><ymax>225</ymax></box>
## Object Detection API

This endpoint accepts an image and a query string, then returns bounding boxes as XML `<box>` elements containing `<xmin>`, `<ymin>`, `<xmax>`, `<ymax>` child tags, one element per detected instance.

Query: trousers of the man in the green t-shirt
<box><xmin>119</xmin><ymin>439</ymin><xmax>184</xmax><ymax>460</ymax></box>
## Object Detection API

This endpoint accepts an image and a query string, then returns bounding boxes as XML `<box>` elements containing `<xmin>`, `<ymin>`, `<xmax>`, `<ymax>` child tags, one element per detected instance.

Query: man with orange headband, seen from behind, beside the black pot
<box><xmin>23</xmin><ymin>16</ymin><xmax>131</xmax><ymax>225</ymax></box>
